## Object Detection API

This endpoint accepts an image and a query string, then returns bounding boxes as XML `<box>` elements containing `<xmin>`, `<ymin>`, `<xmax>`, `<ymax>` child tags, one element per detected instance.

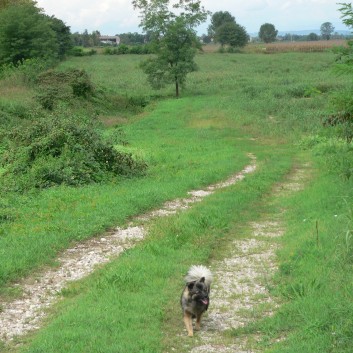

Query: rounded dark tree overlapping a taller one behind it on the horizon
<box><xmin>215</xmin><ymin>22</ymin><xmax>249</xmax><ymax>48</ymax></box>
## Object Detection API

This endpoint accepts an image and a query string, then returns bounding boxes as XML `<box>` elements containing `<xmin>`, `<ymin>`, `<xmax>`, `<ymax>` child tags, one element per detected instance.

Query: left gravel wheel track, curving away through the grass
<box><xmin>0</xmin><ymin>155</ymin><xmax>256</xmax><ymax>342</ymax></box>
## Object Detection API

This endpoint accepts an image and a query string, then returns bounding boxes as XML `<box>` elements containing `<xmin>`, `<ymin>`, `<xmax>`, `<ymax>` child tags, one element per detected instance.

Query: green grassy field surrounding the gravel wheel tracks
<box><xmin>0</xmin><ymin>51</ymin><xmax>353</xmax><ymax>353</ymax></box>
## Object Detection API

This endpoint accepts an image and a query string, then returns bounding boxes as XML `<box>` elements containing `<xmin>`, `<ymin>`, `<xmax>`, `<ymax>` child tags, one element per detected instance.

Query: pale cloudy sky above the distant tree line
<box><xmin>37</xmin><ymin>0</ymin><xmax>349</xmax><ymax>35</ymax></box>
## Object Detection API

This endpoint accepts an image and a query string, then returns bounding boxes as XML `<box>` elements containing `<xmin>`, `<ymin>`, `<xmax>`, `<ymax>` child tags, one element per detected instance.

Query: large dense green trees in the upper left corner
<box><xmin>0</xmin><ymin>1</ymin><xmax>72</xmax><ymax>65</ymax></box>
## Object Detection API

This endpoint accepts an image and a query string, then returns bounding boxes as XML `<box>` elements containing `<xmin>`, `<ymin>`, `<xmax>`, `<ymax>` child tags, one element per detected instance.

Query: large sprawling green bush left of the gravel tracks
<box><xmin>2</xmin><ymin>112</ymin><xmax>146</xmax><ymax>191</ymax></box>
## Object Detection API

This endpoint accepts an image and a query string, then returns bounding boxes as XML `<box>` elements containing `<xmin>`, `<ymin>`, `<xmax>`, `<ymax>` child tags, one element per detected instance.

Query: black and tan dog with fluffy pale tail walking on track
<box><xmin>180</xmin><ymin>265</ymin><xmax>213</xmax><ymax>337</ymax></box>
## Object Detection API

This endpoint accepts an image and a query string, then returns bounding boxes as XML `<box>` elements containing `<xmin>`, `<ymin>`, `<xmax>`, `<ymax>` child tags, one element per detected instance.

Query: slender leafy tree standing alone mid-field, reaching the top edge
<box><xmin>132</xmin><ymin>0</ymin><xmax>208</xmax><ymax>97</ymax></box>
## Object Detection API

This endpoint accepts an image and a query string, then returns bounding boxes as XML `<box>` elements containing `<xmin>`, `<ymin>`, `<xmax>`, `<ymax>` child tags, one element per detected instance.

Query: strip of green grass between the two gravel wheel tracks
<box><xmin>8</xmin><ymin>145</ymin><xmax>292</xmax><ymax>353</ymax></box>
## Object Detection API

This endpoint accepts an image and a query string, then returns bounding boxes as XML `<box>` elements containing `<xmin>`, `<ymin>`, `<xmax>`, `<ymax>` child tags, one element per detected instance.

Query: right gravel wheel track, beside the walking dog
<box><xmin>184</xmin><ymin>161</ymin><xmax>309</xmax><ymax>353</ymax></box>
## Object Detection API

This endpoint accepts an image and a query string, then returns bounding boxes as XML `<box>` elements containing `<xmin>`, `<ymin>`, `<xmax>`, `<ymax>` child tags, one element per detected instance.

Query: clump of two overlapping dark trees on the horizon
<box><xmin>208</xmin><ymin>11</ymin><xmax>249</xmax><ymax>48</ymax></box>
